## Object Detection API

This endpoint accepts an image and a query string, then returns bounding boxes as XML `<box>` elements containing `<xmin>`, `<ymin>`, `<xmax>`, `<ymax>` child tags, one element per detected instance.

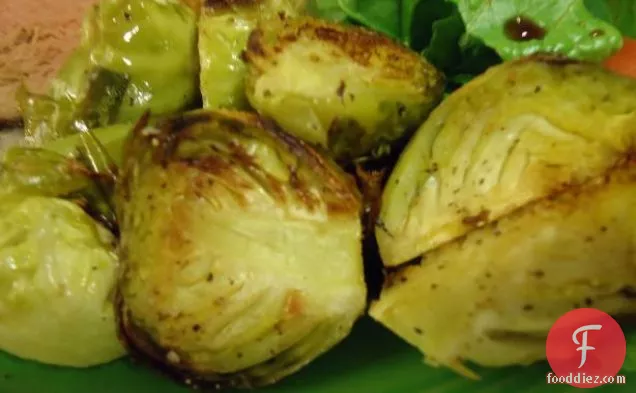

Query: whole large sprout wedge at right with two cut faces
<box><xmin>370</xmin><ymin>57</ymin><xmax>636</xmax><ymax>376</ymax></box>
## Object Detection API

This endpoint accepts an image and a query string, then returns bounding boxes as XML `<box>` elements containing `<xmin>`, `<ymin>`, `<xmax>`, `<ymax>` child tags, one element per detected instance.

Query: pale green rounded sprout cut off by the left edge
<box><xmin>0</xmin><ymin>190</ymin><xmax>125</xmax><ymax>367</ymax></box>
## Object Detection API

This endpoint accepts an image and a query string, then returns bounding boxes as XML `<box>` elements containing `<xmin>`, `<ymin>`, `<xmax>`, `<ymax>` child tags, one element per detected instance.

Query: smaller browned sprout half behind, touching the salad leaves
<box><xmin>245</xmin><ymin>18</ymin><xmax>444</xmax><ymax>160</ymax></box>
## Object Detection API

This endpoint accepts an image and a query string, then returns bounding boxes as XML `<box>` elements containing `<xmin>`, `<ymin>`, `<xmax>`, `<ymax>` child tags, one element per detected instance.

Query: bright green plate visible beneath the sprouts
<box><xmin>0</xmin><ymin>319</ymin><xmax>636</xmax><ymax>393</ymax></box>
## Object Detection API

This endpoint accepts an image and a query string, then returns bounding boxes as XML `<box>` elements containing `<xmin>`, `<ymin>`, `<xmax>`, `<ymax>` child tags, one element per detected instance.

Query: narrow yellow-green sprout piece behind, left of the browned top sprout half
<box><xmin>199</xmin><ymin>0</ymin><xmax>306</xmax><ymax>109</ymax></box>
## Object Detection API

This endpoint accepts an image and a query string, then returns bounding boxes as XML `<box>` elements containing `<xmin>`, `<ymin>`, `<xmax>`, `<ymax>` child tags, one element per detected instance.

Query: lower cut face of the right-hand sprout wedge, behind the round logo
<box><xmin>370</xmin><ymin>163</ymin><xmax>636</xmax><ymax>377</ymax></box>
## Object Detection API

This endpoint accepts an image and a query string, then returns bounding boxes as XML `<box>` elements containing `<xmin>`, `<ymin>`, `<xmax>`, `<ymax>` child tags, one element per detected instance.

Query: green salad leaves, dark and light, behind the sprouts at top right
<box><xmin>310</xmin><ymin>0</ymin><xmax>636</xmax><ymax>90</ymax></box>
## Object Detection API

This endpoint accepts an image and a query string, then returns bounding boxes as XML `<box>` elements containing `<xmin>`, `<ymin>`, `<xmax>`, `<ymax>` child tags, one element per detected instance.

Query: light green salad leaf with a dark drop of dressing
<box><xmin>450</xmin><ymin>0</ymin><xmax>623</xmax><ymax>61</ymax></box>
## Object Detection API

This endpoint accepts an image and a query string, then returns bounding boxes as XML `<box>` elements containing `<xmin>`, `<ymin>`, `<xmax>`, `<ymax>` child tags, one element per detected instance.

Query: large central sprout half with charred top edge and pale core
<box><xmin>117</xmin><ymin>111</ymin><xmax>366</xmax><ymax>387</ymax></box>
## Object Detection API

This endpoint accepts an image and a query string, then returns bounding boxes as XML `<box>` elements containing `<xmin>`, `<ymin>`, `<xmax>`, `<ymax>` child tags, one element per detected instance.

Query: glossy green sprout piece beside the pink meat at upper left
<box><xmin>18</xmin><ymin>0</ymin><xmax>198</xmax><ymax>145</ymax></box>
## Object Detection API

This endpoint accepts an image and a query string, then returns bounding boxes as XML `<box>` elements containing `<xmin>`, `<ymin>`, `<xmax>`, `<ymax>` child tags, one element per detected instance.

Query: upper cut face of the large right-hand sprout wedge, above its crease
<box><xmin>376</xmin><ymin>57</ymin><xmax>636</xmax><ymax>266</ymax></box>
